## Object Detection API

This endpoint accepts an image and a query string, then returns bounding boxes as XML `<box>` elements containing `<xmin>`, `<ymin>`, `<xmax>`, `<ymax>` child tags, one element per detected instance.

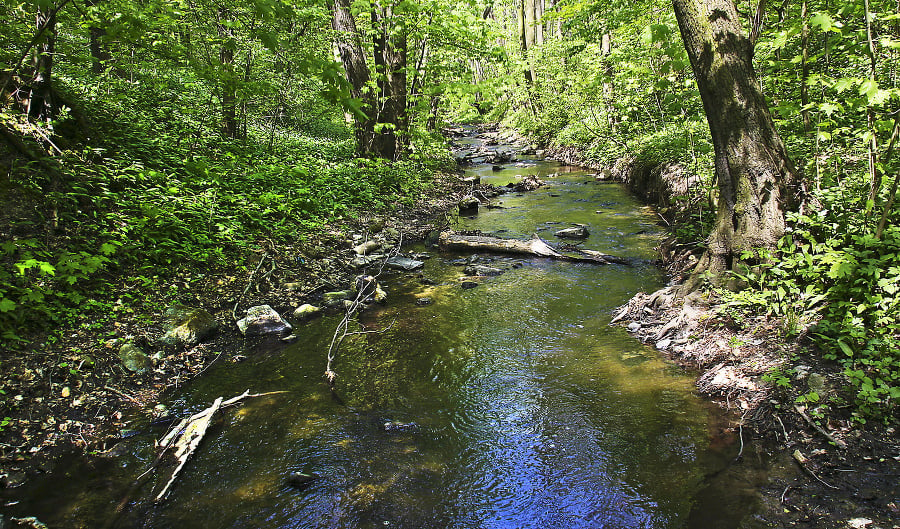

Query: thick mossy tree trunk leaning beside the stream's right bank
<box><xmin>673</xmin><ymin>0</ymin><xmax>798</xmax><ymax>288</ymax></box>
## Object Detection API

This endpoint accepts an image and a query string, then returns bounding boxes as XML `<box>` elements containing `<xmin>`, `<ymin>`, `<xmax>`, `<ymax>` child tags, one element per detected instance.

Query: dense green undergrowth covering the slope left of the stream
<box><xmin>0</xmin><ymin>86</ymin><xmax>450</xmax><ymax>348</ymax></box>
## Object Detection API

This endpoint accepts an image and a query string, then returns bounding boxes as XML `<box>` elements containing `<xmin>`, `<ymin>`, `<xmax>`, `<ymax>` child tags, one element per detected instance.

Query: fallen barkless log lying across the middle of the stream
<box><xmin>438</xmin><ymin>231</ymin><xmax>630</xmax><ymax>264</ymax></box>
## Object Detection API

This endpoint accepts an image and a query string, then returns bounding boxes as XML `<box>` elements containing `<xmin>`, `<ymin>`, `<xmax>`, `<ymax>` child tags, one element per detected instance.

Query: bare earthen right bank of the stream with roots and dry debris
<box><xmin>547</xmin><ymin>134</ymin><xmax>900</xmax><ymax>529</ymax></box>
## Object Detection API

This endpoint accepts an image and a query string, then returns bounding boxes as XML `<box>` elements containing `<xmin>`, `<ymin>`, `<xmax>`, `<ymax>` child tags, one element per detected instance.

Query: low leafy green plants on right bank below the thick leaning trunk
<box><xmin>721</xmin><ymin>188</ymin><xmax>900</xmax><ymax>420</ymax></box>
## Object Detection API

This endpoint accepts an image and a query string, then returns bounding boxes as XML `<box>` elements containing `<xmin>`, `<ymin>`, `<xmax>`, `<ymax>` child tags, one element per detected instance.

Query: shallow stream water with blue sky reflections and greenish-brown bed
<box><xmin>3</xmin><ymin>135</ymin><xmax>766</xmax><ymax>529</ymax></box>
